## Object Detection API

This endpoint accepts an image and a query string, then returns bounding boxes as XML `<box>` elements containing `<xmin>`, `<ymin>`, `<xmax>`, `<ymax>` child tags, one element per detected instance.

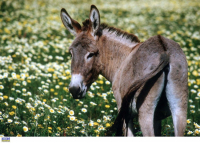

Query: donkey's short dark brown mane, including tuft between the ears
<box><xmin>82</xmin><ymin>19</ymin><xmax>140</xmax><ymax>43</ymax></box>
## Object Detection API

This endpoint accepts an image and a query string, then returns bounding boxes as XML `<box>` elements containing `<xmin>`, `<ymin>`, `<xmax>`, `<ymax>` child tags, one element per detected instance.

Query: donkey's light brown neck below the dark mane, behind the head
<box><xmin>98</xmin><ymin>29</ymin><xmax>139</xmax><ymax>82</ymax></box>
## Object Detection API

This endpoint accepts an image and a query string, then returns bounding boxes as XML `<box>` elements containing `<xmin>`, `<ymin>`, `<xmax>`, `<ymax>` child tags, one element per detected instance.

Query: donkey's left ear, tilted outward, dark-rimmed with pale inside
<box><xmin>60</xmin><ymin>8</ymin><xmax>81</xmax><ymax>36</ymax></box>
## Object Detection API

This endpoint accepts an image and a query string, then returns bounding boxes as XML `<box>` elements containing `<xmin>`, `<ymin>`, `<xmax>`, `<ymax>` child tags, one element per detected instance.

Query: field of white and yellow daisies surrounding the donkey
<box><xmin>0</xmin><ymin>0</ymin><xmax>200</xmax><ymax>137</ymax></box>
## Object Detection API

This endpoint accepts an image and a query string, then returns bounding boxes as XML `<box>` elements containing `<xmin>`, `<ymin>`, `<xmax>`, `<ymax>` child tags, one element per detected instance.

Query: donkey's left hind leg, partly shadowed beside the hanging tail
<box><xmin>137</xmin><ymin>72</ymin><xmax>165</xmax><ymax>136</ymax></box>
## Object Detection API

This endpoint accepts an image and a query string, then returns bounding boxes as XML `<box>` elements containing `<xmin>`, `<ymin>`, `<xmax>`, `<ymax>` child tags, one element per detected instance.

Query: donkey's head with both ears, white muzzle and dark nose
<box><xmin>60</xmin><ymin>5</ymin><xmax>100</xmax><ymax>98</ymax></box>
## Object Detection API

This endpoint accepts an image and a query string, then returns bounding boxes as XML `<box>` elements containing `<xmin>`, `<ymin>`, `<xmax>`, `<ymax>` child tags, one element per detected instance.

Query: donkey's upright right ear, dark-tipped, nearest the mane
<box><xmin>90</xmin><ymin>5</ymin><xmax>100</xmax><ymax>35</ymax></box>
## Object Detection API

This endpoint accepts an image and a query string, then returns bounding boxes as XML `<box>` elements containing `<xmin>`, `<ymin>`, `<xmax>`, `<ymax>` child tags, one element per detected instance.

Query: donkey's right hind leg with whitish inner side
<box><xmin>166</xmin><ymin>65</ymin><xmax>188</xmax><ymax>136</ymax></box>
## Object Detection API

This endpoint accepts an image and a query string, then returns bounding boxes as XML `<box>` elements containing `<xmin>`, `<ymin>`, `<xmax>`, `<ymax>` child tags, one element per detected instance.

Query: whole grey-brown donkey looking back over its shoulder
<box><xmin>60</xmin><ymin>5</ymin><xmax>188</xmax><ymax>136</ymax></box>
